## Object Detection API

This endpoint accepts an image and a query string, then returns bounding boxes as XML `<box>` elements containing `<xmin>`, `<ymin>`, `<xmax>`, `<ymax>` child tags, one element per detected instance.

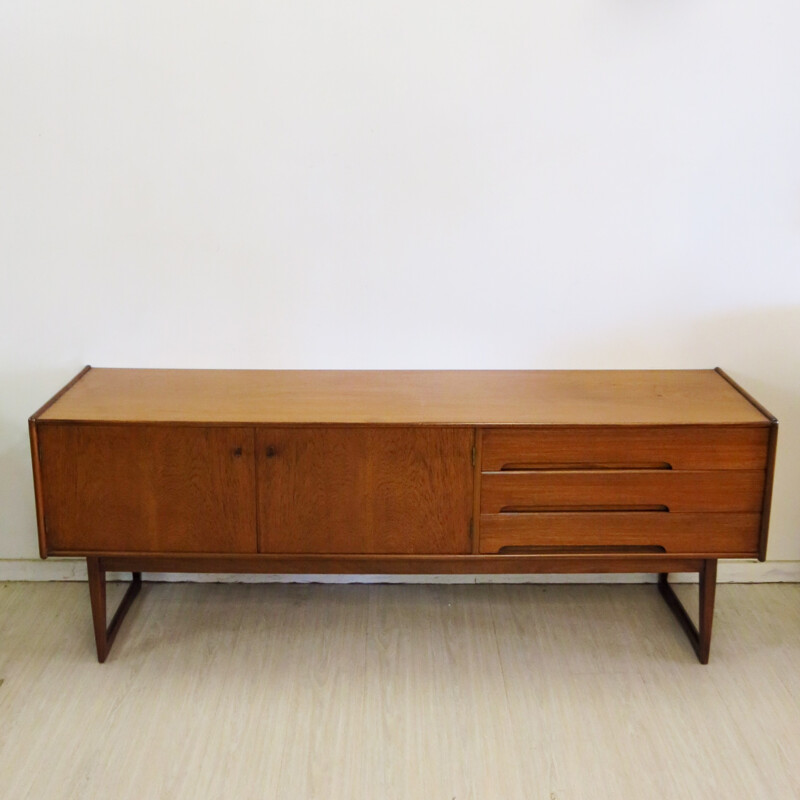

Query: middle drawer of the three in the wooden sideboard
<box><xmin>481</xmin><ymin>470</ymin><xmax>765</xmax><ymax>514</ymax></box>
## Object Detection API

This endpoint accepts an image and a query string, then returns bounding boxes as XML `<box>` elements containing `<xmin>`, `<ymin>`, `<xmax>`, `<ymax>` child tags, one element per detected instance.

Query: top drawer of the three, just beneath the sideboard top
<box><xmin>481</xmin><ymin>425</ymin><xmax>769</xmax><ymax>472</ymax></box>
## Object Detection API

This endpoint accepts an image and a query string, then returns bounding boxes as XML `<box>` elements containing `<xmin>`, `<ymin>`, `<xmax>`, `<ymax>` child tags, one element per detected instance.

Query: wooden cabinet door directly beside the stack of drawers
<box><xmin>256</xmin><ymin>427</ymin><xmax>473</xmax><ymax>554</ymax></box>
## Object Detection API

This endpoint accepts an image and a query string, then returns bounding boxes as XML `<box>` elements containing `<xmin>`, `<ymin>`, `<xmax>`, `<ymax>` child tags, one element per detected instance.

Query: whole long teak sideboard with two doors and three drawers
<box><xmin>30</xmin><ymin>367</ymin><xmax>777</xmax><ymax>664</ymax></box>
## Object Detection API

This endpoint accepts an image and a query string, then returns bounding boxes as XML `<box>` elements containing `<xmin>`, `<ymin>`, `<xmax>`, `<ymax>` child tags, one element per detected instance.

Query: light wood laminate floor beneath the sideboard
<box><xmin>0</xmin><ymin>583</ymin><xmax>800</xmax><ymax>800</ymax></box>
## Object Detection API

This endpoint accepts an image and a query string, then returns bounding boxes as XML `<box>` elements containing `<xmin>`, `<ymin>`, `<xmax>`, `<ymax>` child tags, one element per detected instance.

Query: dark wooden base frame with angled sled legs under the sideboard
<box><xmin>86</xmin><ymin>555</ymin><xmax>717</xmax><ymax>664</ymax></box>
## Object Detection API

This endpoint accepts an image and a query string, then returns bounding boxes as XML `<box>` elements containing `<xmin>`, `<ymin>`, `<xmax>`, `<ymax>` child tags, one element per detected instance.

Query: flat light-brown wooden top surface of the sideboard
<box><xmin>36</xmin><ymin>368</ymin><xmax>769</xmax><ymax>426</ymax></box>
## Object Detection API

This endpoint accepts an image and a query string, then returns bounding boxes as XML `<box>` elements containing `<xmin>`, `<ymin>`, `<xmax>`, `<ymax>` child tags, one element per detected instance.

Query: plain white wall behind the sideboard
<box><xmin>0</xmin><ymin>0</ymin><xmax>800</xmax><ymax>576</ymax></box>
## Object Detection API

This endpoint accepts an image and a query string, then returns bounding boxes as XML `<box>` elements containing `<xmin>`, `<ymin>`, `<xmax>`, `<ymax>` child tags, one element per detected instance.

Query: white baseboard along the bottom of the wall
<box><xmin>0</xmin><ymin>558</ymin><xmax>800</xmax><ymax>583</ymax></box>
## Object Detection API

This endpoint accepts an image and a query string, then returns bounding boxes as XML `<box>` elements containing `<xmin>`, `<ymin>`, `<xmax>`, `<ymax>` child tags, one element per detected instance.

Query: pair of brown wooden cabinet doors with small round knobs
<box><xmin>39</xmin><ymin>424</ymin><xmax>473</xmax><ymax>555</ymax></box>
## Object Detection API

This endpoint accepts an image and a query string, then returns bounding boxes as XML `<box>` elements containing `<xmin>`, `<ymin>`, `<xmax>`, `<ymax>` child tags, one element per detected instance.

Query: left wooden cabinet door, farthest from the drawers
<box><xmin>38</xmin><ymin>424</ymin><xmax>256</xmax><ymax>553</ymax></box>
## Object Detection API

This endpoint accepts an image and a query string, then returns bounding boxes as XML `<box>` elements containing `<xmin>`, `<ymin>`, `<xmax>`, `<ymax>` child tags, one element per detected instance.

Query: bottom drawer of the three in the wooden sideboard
<box><xmin>480</xmin><ymin>512</ymin><xmax>761</xmax><ymax>558</ymax></box>
